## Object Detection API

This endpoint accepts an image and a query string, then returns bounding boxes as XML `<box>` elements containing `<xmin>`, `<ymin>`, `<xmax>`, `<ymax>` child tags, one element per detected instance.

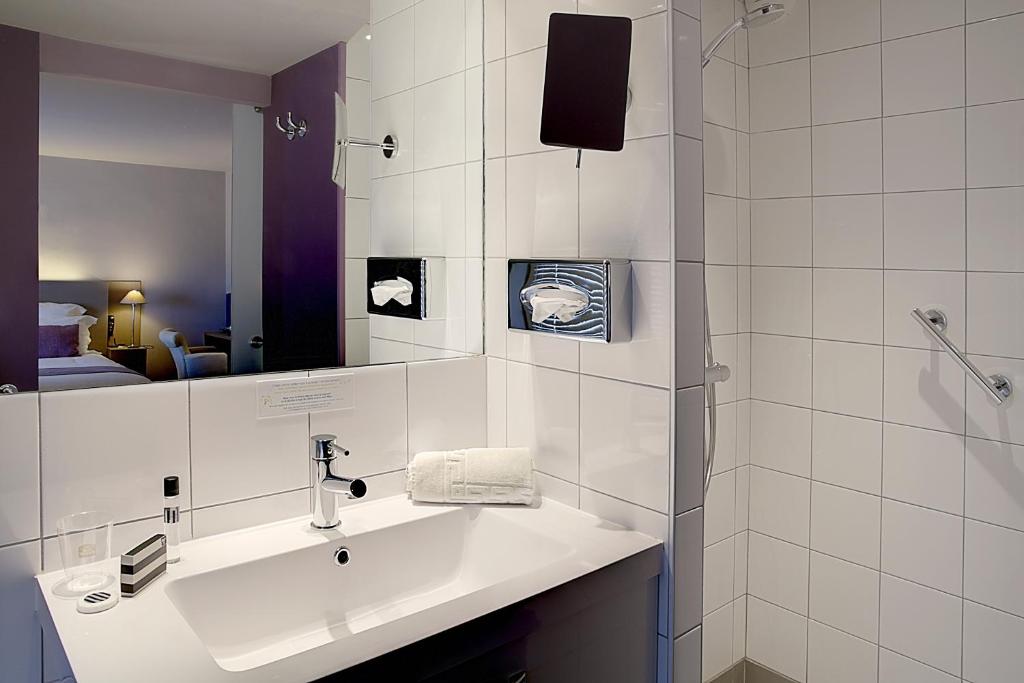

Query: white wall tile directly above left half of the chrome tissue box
<box><xmin>506</xmin><ymin>150</ymin><xmax>581</xmax><ymax>258</ymax></box>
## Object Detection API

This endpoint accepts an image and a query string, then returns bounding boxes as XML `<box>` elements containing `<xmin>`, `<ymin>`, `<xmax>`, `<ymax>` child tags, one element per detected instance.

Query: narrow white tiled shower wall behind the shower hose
<box><xmin>696</xmin><ymin>0</ymin><xmax>753</xmax><ymax>681</ymax></box>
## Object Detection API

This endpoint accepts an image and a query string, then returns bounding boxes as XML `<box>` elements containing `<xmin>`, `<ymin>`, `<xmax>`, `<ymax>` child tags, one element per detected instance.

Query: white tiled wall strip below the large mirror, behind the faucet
<box><xmin>0</xmin><ymin>356</ymin><xmax>487</xmax><ymax>683</ymax></box>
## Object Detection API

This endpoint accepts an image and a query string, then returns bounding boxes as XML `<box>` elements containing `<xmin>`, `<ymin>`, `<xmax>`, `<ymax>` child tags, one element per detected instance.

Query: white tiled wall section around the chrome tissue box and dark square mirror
<box><xmin>484</xmin><ymin>0</ymin><xmax>704</xmax><ymax>680</ymax></box>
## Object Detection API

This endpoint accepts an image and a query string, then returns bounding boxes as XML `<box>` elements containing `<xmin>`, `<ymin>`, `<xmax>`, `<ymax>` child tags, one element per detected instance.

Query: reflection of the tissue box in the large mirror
<box><xmin>367</xmin><ymin>257</ymin><xmax>445</xmax><ymax>321</ymax></box>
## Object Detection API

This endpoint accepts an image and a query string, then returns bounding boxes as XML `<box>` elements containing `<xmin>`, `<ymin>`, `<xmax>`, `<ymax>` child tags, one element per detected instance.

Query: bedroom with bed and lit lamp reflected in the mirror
<box><xmin>39</xmin><ymin>73</ymin><xmax>241</xmax><ymax>391</ymax></box>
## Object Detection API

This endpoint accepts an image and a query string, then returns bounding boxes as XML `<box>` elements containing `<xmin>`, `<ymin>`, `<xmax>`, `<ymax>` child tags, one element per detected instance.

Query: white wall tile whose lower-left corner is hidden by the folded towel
<box><xmin>506</xmin><ymin>362</ymin><xmax>580</xmax><ymax>482</ymax></box>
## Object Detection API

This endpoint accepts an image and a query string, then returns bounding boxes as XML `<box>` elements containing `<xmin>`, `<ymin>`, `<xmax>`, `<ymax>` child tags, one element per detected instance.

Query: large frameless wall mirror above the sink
<box><xmin>0</xmin><ymin>0</ymin><xmax>483</xmax><ymax>391</ymax></box>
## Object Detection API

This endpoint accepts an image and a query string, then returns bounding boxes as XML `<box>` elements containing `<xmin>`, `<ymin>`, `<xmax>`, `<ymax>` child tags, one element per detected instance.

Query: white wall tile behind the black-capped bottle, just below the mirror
<box><xmin>39</xmin><ymin>382</ymin><xmax>191</xmax><ymax>535</ymax></box>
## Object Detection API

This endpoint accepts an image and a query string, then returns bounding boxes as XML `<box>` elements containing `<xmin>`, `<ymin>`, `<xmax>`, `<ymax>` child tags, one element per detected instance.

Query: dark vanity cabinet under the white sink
<box><xmin>316</xmin><ymin>547</ymin><xmax>662</xmax><ymax>683</ymax></box>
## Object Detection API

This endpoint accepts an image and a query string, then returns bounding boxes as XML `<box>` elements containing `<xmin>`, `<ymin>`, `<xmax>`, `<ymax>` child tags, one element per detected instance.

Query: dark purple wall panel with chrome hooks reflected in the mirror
<box><xmin>263</xmin><ymin>43</ymin><xmax>345</xmax><ymax>371</ymax></box>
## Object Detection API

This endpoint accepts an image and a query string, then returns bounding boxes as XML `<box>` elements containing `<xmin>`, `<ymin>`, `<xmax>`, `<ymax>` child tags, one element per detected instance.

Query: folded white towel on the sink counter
<box><xmin>406</xmin><ymin>449</ymin><xmax>534</xmax><ymax>505</ymax></box>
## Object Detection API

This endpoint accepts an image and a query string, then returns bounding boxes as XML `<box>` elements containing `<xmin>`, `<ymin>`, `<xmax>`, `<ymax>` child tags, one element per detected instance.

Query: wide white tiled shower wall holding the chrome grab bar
<box><xmin>741</xmin><ymin>0</ymin><xmax>1024</xmax><ymax>683</ymax></box>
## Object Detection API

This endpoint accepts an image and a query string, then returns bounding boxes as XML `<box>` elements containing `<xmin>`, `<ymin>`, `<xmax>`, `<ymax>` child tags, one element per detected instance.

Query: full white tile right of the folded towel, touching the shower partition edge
<box><xmin>580</xmin><ymin>376</ymin><xmax>670</xmax><ymax>512</ymax></box>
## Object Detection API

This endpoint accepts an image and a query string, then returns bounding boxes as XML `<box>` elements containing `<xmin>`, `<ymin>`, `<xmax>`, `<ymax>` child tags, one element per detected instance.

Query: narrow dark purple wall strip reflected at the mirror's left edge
<box><xmin>0</xmin><ymin>25</ymin><xmax>39</xmax><ymax>391</ymax></box>
